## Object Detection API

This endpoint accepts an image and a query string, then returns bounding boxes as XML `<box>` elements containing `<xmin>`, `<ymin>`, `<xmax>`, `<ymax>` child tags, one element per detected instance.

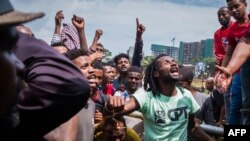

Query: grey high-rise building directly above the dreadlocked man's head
<box><xmin>151</xmin><ymin>44</ymin><xmax>179</xmax><ymax>60</ymax></box>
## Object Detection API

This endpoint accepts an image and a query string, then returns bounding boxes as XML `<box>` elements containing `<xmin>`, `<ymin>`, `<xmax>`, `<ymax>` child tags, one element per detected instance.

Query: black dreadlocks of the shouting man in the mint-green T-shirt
<box><xmin>144</xmin><ymin>54</ymin><xmax>168</xmax><ymax>96</ymax></box>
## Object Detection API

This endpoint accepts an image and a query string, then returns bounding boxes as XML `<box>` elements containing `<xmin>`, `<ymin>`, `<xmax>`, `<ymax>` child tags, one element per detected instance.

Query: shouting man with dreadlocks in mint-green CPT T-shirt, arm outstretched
<box><xmin>106</xmin><ymin>54</ymin><xmax>212</xmax><ymax>141</ymax></box>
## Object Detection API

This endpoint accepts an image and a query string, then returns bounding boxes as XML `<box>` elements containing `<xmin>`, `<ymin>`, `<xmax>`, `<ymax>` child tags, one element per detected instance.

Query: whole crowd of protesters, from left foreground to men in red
<box><xmin>0</xmin><ymin>0</ymin><xmax>250</xmax><ymax>141</ymax></box>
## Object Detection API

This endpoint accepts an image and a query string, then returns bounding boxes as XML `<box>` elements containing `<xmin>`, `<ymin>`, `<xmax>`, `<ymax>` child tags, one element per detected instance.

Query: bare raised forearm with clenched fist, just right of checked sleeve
<box><xmin>71</xmin><ymin>15</ymin><xmax>88</xmax><ymax>51</ymax></box>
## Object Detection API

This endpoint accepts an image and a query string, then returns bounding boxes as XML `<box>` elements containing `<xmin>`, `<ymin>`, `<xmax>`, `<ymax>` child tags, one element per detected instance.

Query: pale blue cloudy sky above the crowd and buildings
<box><xmin>10</xmin><ymin>0</ymin><xmax>247</xmax><ymax>56</ymax></box>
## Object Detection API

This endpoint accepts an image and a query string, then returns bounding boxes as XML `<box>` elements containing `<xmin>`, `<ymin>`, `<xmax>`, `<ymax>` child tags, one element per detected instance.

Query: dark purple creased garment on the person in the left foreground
<box><xmin>14</xmin><ymin>34</ymin><xmax>90</xmax><ymax>139</ymax></box>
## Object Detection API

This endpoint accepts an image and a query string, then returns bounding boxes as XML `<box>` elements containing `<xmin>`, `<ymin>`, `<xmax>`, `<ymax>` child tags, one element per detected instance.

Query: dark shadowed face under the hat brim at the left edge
<box><xmin>0</xmin><ymin>28</ymin><xmax>24</xmax><ymax>117</ymax></box>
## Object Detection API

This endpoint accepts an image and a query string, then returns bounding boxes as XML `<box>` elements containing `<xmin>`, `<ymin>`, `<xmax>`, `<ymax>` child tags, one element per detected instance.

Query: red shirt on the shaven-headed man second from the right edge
<box><xmin>214</xmin><ymin>22</ymin><xmax>233</xmax><ymax>65</ymax></box>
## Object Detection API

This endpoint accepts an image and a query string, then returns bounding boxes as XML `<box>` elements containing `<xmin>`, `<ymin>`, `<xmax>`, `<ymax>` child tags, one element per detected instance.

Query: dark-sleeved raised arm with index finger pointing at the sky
<box><xmin>132</xmin><ymin>18</ymin><xmax>146</xmax><ymax>67</ymax></box>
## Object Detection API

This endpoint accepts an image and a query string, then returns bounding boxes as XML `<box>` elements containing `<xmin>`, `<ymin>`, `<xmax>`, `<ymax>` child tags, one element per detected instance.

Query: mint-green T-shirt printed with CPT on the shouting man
<box><xmin>133</xmin><ymin>88</ymin><xmax>200</xmax><ymax>141</ymax></box>
